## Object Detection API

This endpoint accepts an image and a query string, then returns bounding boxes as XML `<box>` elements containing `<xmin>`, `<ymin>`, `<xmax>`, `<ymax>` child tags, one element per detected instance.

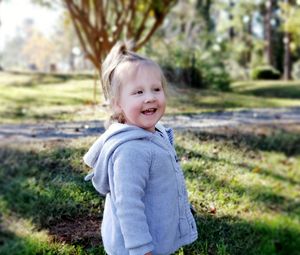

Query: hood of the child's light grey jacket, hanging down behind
<box><xmin>83</xmin><ymin>123</ymin><xmax>162</xmax><ymax>195</ymax></box>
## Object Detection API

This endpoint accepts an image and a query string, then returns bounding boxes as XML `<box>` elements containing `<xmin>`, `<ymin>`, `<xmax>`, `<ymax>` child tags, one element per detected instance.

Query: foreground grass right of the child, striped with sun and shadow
<box><xmin>177</xmin><ymin>130</ymin><xmax>300</xmax><ymax>254</ymax></box>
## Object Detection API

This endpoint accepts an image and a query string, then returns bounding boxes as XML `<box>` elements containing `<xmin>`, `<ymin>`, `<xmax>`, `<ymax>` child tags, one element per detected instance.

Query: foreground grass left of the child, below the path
<box><xmin>0</xmin><ymin>138</ymin><xmax>104</xmax><ymax>254</ymax></box>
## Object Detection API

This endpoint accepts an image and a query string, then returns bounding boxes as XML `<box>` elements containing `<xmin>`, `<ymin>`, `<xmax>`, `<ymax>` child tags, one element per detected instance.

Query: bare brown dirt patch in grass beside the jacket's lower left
<box><xmin>49</xmin><ymin>216</ymin><xmax>102</xmax><ymax>247</ymax></box>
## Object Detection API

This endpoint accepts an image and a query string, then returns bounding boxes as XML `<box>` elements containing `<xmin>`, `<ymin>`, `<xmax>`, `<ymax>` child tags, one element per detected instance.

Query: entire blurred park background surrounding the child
<box><xmin>0</xmin><ymin>0</ymin><xmax>300</xmax><ymax>255</ymax></box>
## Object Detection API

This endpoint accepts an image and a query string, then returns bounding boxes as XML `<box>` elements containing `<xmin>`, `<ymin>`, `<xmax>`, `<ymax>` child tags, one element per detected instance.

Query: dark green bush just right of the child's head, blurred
<box><xmin>153</xmin><ymin>42</ymin><xmax>231</xmax><ymax>91</ymax></box>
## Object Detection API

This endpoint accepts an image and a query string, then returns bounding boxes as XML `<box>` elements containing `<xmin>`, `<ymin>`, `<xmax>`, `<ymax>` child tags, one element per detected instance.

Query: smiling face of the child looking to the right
<box><xmin>115</xmin><ymin>63</ymin><xmax>166</xmax><ymax>132</ymax></box>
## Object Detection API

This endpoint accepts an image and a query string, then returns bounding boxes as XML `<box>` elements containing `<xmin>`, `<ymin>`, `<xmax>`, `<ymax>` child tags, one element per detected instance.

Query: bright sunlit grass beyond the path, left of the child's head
<box><xmin>0</xmin><ymin>73</ymin><xmax>106</xmax><ymax>123</ymax></box>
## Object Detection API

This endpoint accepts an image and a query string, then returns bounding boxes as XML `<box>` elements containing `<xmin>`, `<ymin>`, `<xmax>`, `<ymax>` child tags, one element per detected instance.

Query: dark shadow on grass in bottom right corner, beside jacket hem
<box><xmin>183</xmin><ymin>214</ymin><xmax>300</xmax><ymax>255</ymax></box>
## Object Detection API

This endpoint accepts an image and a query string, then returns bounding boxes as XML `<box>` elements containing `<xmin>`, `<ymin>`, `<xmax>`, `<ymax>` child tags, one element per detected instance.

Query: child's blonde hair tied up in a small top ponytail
<box><xmin>101</xmin><ymin>41</ymin><xmax>167</xmax><ymax>124</ymax></box>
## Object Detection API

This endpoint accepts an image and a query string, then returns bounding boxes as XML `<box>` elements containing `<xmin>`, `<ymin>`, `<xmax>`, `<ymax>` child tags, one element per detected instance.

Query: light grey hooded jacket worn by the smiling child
<box><xmin>84</xmin><ymin>123</ymin><xmax>197</xmax><ymax>255</ymax></box>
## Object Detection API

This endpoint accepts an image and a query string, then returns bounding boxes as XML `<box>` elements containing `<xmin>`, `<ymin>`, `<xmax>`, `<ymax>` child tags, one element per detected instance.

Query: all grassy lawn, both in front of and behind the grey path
<box><xmin>0</xmin><ymin>73</ymin><xmax>300</xmax><ymax>255</ymax></box>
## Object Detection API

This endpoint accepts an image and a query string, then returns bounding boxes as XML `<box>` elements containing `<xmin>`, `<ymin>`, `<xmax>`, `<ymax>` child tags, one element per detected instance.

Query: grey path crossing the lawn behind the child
<box><xmin>0</xmin><ymin>107</ymin><xmax>300</xmax><ymax>142</ymax></box>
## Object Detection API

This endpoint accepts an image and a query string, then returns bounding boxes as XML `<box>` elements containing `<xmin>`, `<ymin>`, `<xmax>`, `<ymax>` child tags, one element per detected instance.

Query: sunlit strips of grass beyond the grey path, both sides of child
<box><xmin>0</xmin><ymin>72</ymin><xmax>300</xmax><ymax>123</ymax></box>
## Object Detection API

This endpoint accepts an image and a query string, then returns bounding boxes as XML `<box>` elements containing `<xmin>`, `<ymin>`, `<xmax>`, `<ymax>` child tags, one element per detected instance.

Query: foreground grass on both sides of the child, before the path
<box><xmin>0</xmin><ymin>126</ymin><xmax>300</xmax><ymax>255</ymax></box>
